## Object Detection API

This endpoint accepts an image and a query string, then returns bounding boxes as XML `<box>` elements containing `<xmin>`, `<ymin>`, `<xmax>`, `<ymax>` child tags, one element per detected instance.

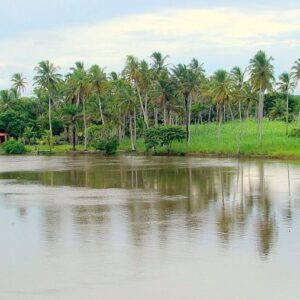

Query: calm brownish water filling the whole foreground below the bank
<box><xmin>0</xmin><ymin>155</ymin><xmax>300</xmax><ymax>300</ymax></box>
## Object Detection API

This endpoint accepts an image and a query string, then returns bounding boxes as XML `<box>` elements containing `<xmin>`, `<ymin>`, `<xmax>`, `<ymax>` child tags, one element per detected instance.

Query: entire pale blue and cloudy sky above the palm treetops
<box><xmin>0</xmin><ymin>0</ymin><xmax>300</xmax><ymax>93</ymax></box>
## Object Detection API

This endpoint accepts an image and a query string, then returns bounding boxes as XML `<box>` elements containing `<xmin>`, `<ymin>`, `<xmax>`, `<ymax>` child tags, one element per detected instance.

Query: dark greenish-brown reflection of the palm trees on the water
<box><xmin>0</xmin><ymin>156</ymin><xmax>300</xmax><ymax>257</ymax></box>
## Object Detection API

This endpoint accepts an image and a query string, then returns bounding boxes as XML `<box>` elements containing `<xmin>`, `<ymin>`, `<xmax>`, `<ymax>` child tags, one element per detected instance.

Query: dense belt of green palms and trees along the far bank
<box><xmin>0</xmin><ymin>51</ymin><xmax>300</xmax><ymax>153</ymax></box>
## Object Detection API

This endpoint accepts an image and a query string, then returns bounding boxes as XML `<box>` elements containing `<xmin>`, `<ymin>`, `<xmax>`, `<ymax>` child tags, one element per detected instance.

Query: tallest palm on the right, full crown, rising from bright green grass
<box><xmin>249</xmin><ymin>50</ymin><xmax>274</xmax><ymax>142</ymax></box>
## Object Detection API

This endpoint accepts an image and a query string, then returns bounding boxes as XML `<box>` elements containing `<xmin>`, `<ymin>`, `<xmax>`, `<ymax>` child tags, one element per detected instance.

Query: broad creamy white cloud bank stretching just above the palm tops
<box><xmin>0</xmin><ymin>9</ymin><xmax>300</xmax><ymax>92</ymax></box>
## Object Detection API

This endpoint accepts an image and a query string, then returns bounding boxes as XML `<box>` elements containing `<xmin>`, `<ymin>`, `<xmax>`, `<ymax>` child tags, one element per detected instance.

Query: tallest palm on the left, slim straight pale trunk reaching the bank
<box><xmin>33</xmin><ymin>60</ymin><xmax>61</xmax><ymax>148</ymax></box>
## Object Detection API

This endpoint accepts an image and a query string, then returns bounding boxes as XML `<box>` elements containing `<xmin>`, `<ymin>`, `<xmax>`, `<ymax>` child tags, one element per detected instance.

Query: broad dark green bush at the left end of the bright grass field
<box><xmin>145</xmin><ymin>125</ymin><xmax>186</xmax><ymax>152</ymax></box>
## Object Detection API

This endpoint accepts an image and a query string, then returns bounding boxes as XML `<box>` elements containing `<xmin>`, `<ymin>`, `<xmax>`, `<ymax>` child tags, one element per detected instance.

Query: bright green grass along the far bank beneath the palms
<box><xmin>3</xmin><ymin>121</ymin><xmax>300</xmax><ymax>158</ymax></box>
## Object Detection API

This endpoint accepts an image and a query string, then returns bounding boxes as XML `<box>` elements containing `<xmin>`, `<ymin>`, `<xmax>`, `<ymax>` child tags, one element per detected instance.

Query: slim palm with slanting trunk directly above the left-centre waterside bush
<box><xmin>89</xmin><ymin>65</ymin><xmax>107</xmax><ymax>125</ymax></box>
